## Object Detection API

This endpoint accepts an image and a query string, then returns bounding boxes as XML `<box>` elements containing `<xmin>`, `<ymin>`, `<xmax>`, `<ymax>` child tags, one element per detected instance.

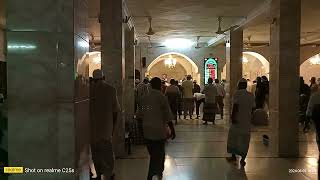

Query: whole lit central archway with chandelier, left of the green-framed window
<box><xmin>145</xmin><ymin>52</ymin><xmax>201</xmax><ymax>83</ymax></box>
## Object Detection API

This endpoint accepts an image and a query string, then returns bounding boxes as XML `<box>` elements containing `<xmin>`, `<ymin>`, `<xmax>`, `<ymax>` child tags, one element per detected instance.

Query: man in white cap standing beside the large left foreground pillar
<box><xmin>90</xmin><ymin>69</ymin><xmax>120</xmax><ymax>180</ymax></box>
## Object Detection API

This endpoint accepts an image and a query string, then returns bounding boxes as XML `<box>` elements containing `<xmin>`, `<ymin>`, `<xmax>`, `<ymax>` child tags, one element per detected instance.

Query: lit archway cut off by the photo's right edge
<box><xmin>300</xmin><ymin>54</ymin><xmax>320</xmax><ymax>84</ymax></box>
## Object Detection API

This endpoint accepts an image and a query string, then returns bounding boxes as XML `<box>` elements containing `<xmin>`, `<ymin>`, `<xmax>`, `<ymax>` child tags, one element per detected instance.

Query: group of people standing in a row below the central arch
<box><xmin>135</xmin><ymin>75</ymin><xmax>226</xmax><ymax>124</ymax></box>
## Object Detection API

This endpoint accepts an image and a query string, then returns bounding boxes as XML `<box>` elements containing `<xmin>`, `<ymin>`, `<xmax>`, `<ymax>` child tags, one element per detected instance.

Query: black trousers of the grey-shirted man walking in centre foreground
<box><xmin>146</xmin><ymin>140</ymin><xmax>165</xmax><ymax>180</ymax></box>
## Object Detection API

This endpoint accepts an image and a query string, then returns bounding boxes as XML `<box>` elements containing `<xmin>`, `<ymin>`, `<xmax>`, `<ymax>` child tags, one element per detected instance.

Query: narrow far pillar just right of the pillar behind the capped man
<box><xmin>124</xmin><ymin>28</ymin><xmax>135</xmax><ymax>122</ymax></box>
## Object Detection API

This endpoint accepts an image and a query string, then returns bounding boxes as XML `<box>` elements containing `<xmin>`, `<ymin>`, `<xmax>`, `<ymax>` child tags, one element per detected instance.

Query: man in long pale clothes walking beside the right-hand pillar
<box><xmin>227</xmin><ymin>79</ymin><xmax>255</xmax><ymax>166</ymax></box>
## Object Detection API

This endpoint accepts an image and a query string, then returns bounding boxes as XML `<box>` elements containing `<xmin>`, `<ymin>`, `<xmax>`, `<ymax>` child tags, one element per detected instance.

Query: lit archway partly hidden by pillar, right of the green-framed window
<box><xmin>221</xmin><ymin>51</ymin><xmax>270</xmax><ymax>81</ymax></box>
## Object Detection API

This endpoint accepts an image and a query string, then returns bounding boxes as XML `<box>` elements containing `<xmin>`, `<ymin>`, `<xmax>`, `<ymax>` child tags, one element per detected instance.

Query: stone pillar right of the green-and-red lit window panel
<box><xmin>226</xmin><ymin>28</ymin><xmax>243</xmax><ymax>118</ymax></box>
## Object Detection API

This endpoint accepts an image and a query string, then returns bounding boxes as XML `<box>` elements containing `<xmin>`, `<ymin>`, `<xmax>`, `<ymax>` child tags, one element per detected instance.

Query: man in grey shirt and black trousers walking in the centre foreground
<box><xmin>139</xmin><ymin>78</ymin><xmax>175</xmax><ymax>180</ymax></box>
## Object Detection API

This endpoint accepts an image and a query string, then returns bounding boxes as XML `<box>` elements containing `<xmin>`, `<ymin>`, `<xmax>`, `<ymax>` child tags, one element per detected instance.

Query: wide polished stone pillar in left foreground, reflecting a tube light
<box><xmin>6</xmin><ymin>0</ymin><xmax>89</xmax><ymax>180</ymax></box>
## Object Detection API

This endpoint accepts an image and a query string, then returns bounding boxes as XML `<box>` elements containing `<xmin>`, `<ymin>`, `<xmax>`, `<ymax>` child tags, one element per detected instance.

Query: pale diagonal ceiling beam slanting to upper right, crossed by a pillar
<box><xmin>207</xmin><ymin>0</ymin><xmax>272</xmax><ymax>46</ymax></box>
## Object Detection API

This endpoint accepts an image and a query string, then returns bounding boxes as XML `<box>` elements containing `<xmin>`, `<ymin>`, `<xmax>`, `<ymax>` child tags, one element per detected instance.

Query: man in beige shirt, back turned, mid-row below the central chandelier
<box><xmin>182</xmin><ymin>75</ymin><xmax>194</xmax><ymax>119</ymax></box>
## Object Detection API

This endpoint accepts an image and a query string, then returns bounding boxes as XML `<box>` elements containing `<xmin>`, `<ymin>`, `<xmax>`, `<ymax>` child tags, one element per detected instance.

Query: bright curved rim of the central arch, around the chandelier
<box><xmin>145</xmin><ymin>52</ymin><xmax>201</xmax><ymax>83</ymax></box>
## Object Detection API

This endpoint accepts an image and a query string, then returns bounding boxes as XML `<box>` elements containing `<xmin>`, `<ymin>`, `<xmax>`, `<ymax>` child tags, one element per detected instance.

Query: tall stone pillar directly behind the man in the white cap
<box><xmin>100</xmin><ymin>0</ymin><xmax>125</xmax><ymax>156</ymax></box>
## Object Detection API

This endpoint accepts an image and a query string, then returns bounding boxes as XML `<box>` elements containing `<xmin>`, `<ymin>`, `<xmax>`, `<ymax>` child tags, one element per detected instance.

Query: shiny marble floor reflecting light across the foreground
<box><xmin>116</xmin><ymin>116</ymin><xmax>318</xmax><ymax>180</ymax></box>
